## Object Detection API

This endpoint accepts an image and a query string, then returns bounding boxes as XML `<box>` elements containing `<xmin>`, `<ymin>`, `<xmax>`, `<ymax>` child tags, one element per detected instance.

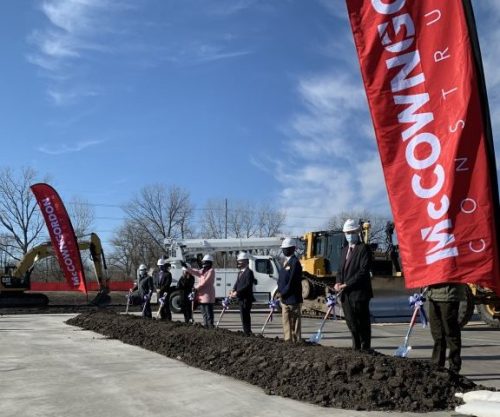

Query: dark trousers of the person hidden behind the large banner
<box><xmin>429</xmin><ymin>300</ymin><xmax>462</xmax><ymax>373</ymax></box>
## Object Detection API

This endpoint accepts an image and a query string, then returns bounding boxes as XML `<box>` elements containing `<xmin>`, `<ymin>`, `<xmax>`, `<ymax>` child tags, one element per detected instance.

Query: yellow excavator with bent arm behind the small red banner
<box><xmin>0</xmin><ymin>233</ymin><xmax>110</xmax><ymax>307</ymax></box>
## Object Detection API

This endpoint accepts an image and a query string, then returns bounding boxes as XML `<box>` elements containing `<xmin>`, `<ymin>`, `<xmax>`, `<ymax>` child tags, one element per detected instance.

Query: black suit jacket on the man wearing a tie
<box><xmin>336</xmin><ymin>243</ymin><xmax>373</xmax><ymax>301</ymax></box>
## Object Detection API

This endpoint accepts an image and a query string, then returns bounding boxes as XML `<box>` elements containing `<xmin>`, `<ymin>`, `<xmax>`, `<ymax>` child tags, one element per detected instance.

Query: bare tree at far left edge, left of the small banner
<box><xmin>0</xmin><ymin>168</ymin><xmax>45</xmax><ymax>260</ymax></box>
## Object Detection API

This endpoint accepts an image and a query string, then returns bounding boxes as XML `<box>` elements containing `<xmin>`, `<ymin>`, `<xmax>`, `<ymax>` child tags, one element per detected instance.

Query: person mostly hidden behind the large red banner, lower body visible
<box><xmin>427</xmin><ymin>283</ymin><xmax>466</xmax><ymax>374</ymax></box>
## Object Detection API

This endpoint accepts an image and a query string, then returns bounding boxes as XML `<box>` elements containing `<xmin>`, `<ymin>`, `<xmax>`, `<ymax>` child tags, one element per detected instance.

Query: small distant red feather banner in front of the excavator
<box><xmin>31</xmin><ymin>184</ymin><xmax>87</xmax><ymax>293</ymax></box>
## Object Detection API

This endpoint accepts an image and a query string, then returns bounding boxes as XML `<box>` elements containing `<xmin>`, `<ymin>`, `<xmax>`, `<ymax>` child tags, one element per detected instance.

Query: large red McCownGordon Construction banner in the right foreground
<box><xmin>347</xmin><ymin>0</ymin><xmax>500</xmax><ymax>293</ymax></box>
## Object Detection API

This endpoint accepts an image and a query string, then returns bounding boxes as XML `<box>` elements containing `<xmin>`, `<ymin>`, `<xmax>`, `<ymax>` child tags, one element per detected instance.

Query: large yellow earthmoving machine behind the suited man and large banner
<box><xmin>300</xmin><ymin>221</ymin><xmax>500</xmax><ymax>328</ymax></box>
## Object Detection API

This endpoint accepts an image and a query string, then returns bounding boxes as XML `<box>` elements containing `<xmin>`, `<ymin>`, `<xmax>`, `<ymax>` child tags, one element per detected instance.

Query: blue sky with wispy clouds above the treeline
<box><xmin>0</xmin><ymin>0</ymin><xmax>500</xmax><ymax>245</ymax></box>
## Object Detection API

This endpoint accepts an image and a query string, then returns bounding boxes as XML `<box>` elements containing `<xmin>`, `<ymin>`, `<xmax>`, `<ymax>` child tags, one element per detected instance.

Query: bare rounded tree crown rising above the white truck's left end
<box><xmin>124</xmin><ymin>184</ymin><xmax>193</xmax><ymax>248</ymax></box>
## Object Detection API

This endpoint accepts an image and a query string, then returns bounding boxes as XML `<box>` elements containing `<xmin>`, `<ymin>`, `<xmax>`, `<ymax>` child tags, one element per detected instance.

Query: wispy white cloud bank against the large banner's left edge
<box><xmin>268</xmin><ymin>70</ymin><xmax>380</xmax><ymax>234</ymax></box>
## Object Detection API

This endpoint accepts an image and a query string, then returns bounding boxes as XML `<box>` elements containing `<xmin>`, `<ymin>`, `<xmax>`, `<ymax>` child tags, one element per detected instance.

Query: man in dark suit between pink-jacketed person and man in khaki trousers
<box><xmin>229</xmin><ymin>252</ymin><xmax>255</xmax><ymax>336</ymax></box>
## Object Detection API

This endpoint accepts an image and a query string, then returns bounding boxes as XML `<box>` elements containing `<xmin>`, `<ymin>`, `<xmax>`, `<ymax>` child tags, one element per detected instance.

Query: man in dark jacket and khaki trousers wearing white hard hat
<box><xmin>278</xmin><ymin>238</ymin><xmax>303</xmax><ymax>342</ymax></box>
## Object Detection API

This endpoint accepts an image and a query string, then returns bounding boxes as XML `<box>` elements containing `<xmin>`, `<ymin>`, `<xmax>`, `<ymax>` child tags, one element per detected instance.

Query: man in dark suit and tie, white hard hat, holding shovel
<box><xmin>334</xmin><ymin>219</ymin><xmax>373</xmax><ymax>351</ymax></box>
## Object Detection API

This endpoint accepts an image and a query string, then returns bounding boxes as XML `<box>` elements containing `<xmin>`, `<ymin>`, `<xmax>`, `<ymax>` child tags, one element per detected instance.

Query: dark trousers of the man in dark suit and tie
<box><xmin>342</xmin><ymin>294</ymin><xmax>372</xmax><ymax>350</ymax></box>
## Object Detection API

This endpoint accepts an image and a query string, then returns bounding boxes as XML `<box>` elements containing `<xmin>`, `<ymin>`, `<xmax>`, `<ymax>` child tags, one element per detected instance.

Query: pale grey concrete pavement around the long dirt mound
<box><xmin>0</xmin><ymin>313</ymin><xmax>500</xmax><ymax>417</ymax></box>
